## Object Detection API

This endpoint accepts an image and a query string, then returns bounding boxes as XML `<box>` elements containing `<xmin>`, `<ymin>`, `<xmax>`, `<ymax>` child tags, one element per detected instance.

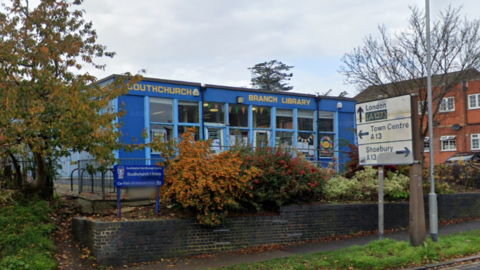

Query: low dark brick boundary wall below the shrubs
<box><xmin>72</xmin><ymin>193</ymin><xmax>480</xmax><ymax>265</ymax></box>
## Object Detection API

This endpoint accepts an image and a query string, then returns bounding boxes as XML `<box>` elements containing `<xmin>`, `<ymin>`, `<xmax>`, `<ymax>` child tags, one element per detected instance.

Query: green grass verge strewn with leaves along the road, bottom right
<box><xmin>223</xmin><ymin>231</ymin><xmax>480</xmax><ymax>270</ymax></box>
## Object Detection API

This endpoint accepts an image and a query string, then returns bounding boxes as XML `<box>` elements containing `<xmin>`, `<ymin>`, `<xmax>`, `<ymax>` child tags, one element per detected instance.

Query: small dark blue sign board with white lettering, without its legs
<box><xmin>113</xmin><ymin>165</ymin><xmax>164</xmax><ymax>187</ymax></box>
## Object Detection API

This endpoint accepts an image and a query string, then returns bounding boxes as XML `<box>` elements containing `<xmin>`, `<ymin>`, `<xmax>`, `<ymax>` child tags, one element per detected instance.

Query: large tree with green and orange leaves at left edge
<box><xmin>0</xmin><ymin>0</ymin><xmax>140</xmax><ymax>195</ymax></box>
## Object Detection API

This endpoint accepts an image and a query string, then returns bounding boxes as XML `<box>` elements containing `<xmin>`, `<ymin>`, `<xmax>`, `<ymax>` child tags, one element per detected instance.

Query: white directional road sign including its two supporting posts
<box><xmin>355</xmin><ymin>95</ymin><xmax>425</xmax><ymax>245</ymax></box>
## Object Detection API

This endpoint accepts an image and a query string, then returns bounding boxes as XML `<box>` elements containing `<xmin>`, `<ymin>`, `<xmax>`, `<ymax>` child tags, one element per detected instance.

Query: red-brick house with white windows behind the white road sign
<box><xmin>355</xmin><ymin>69</ymin><xmax>480</xmax><ymax>163</ymax></box>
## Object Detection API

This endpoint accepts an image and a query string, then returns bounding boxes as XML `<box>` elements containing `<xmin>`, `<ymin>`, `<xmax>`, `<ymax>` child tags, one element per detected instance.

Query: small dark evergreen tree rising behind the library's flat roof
<box><xmin>248</xmin><ymin>60</ymin><xmax>294</xmax><ymax>91</ymax></box>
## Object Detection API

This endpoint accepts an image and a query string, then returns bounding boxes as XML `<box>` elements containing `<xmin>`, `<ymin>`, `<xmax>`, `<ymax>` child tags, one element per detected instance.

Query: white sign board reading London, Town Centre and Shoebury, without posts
<box><xmin>355</xmin><ymin>95</ymin><xmax>413</xmax><ymax>166</ymax></box>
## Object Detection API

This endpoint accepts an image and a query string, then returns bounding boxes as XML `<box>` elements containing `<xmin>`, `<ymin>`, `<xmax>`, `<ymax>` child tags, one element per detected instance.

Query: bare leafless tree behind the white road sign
<box><xmin>339</xmin><ymin>7</ymin><xmax>480</xmax><ymax>136</ymax></box>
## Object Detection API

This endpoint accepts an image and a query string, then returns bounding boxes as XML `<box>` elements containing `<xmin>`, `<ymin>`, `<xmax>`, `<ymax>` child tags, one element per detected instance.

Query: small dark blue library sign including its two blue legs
<box><xmin>113</xmin><ymin>165</ymin><xmax>164</xmax><ymax>220</ymax></box>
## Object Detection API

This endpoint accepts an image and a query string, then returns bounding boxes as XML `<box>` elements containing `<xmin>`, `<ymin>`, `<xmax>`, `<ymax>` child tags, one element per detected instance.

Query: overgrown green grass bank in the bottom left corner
<box><xmin>0</xmin><ymin>201</ymin><xmax>57</xmax><ymax>270</ymax></box>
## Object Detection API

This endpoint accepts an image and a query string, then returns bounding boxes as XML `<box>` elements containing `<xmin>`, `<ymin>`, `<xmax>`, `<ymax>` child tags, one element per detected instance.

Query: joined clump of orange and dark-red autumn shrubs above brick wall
<box><xmin>162</xmin><ymin>130</ymin><xmax>334</xmax><ymax>226</ymax></box>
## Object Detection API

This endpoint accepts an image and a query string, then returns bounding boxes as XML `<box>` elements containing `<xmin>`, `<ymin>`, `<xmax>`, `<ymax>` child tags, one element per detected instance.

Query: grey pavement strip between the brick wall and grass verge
<box><xmin>119</xmin><ymin>219</ymin><xmax>480</xmax><ymax>270</ymax></box>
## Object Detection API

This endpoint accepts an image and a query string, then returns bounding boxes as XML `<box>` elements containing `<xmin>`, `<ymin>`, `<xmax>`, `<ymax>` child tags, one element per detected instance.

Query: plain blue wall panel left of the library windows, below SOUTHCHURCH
<box><xmin>118</xmin><ymin>96</ymin><xmax>145</xmax><ymax>158</ymax></box>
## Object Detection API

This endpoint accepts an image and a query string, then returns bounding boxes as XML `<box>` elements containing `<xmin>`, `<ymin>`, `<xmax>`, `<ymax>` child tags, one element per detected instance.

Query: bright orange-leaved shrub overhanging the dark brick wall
<box><xmin>162</xmin><ymin>130</ymin><xmax>260</xmax><ymax>226</ymax></box>
